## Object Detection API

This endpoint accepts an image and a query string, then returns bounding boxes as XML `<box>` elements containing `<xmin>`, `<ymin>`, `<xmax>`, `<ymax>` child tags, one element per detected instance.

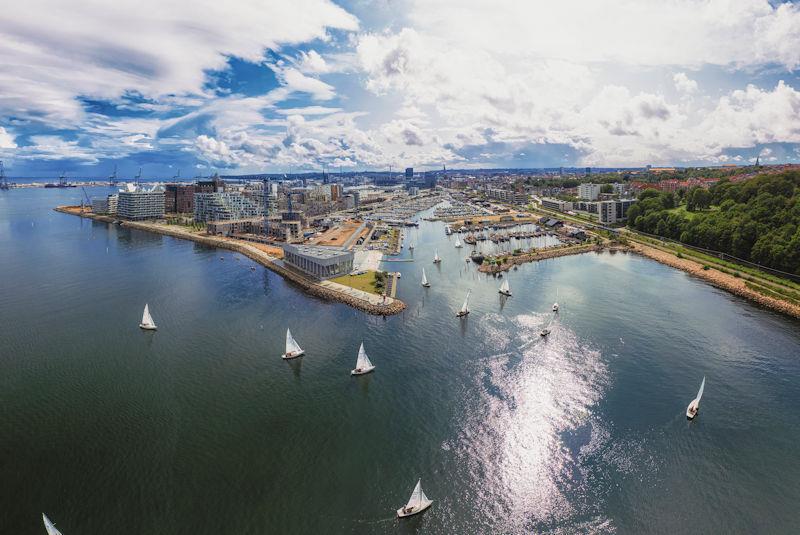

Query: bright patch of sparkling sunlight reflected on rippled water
<box><xmin>449</xmin><ymin>314</ymin><xmax>613</xmax><ymax>533</ymax></box>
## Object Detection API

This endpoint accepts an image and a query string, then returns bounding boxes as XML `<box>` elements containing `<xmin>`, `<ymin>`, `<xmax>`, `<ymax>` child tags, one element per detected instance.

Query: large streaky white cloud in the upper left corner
<box><xmin>0</xmin><ymin>0</ymin><xmax>358</xmax><ymax>127</ymax></box>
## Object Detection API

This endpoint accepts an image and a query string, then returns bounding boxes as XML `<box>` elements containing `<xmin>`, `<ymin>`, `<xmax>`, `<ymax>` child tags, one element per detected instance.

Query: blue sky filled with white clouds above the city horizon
<box><xmin>0</xmin><ymin>0</ymin><xmax>800</xmax><ymax>178</ymax></box>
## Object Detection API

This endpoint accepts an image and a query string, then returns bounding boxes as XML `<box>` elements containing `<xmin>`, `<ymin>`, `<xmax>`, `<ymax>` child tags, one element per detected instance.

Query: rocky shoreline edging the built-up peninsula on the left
<box><xmin>53</xmin><ymin>206</ymin><xmax>406</xmax><ymax>316</ymax></box>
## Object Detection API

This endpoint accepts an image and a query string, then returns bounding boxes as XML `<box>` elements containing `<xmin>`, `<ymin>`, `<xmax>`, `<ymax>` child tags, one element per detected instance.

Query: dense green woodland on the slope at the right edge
<box><xmin>628</xmin><ymin>171</ymin><xmax>800</xmax><ymax>275</ymax></box>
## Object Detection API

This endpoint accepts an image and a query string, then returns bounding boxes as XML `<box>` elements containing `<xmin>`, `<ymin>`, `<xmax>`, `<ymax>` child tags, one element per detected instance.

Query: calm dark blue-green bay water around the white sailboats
<box><xmin>0</xmin><ymin>189</ymin><xmax>800</xmax><ymax>535</ymax></box>
